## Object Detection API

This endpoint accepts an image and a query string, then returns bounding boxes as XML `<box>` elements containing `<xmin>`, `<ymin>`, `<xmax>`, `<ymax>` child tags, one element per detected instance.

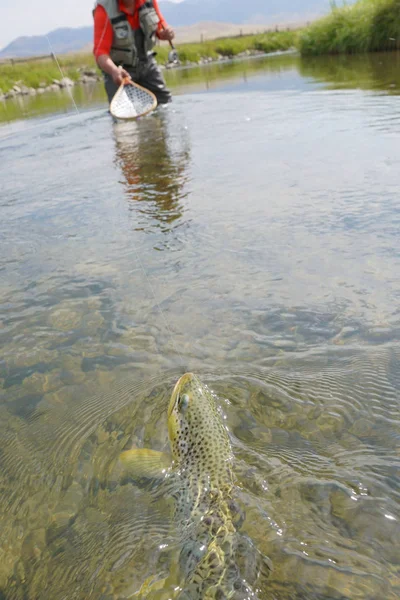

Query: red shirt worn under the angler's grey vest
<box><xmin>93</xmin><ymin>0</ymin><xmax>167</xmax><ymax>58</ymax></box>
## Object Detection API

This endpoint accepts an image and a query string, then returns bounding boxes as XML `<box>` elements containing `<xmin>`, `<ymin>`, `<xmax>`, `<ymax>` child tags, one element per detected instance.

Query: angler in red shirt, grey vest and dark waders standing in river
<box><xmin>93</xmin><ymin>0</ymin><xmax>174</xmax><ymax>104</ymax></box>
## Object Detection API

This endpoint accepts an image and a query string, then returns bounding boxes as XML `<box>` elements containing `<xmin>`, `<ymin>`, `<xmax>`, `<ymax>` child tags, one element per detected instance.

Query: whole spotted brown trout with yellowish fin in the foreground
<box><xmin>121</xmin><ymin>373</ymin><xmax>268</xmax><ymax>600</ymax></box>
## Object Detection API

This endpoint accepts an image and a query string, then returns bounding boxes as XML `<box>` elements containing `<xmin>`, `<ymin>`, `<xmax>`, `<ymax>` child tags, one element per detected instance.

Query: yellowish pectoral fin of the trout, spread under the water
<box><xmin>119</xmin><ymin>448</ymin><xmax>171</xmax><ymax>479</ymax></box>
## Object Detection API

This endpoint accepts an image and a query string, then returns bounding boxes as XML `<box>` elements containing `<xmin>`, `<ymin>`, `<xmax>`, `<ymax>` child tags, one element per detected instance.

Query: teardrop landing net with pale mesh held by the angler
<box><xmin>110</xmin><ymin>83</ymin><xmax>157</xmax><ymax>119</ymax></box>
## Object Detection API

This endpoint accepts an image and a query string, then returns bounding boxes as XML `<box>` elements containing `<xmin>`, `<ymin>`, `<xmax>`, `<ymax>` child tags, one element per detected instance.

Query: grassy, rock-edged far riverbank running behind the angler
<box><xmin>0</xmin><ymin>30</ymin><xmax>298</xmax><ymax>100</ymax></box>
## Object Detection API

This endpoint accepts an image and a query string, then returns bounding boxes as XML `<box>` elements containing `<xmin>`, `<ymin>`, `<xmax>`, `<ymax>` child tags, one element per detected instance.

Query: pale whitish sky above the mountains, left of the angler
<box><xmin>0</xmin><ymin>0</ymin><xmax>183</xmax><ymax>49</ymax></box>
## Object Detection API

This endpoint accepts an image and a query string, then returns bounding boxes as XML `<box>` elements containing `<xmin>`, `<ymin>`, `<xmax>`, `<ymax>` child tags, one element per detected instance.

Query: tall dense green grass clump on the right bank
<box><xmin>298</xmin><ymin>0</ymin><xmax>400</xmax><ymax>56</ymax></box>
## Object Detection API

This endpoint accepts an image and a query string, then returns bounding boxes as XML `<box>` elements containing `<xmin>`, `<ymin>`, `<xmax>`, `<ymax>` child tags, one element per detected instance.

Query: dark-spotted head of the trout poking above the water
<box><xmin>168</xmin><ymin>373</ymin><xmax>231</xmax><ymax>471</ymax></box>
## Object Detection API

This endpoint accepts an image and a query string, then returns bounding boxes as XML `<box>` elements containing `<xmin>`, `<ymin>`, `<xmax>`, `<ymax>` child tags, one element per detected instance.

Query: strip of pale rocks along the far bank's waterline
<box><xmin>0</xmin><ymin>50</ymin><xmax>276</xmax><ymax>101</ymax></box>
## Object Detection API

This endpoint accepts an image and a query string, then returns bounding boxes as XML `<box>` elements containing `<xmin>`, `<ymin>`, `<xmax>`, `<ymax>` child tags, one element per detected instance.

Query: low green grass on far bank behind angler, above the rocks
<box><xmin>0</xmin><ymin>31</ymin><xmax>298</xmax><ymax>92</ymax></box>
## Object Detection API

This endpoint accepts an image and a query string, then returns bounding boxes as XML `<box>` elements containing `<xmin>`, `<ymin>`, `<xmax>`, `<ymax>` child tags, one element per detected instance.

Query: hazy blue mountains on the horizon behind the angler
<box><xmin>0</xmin><ymin>0</ymin><xmax>330</xmax><ymax>58</ymax></box>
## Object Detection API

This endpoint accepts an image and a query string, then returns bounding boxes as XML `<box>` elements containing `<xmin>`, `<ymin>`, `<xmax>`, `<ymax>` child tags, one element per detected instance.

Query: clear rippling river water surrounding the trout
<box><xmin>0</xmin><ymin>57</ymin><xmax>400</xmax><ymax>600</ymax></box>
